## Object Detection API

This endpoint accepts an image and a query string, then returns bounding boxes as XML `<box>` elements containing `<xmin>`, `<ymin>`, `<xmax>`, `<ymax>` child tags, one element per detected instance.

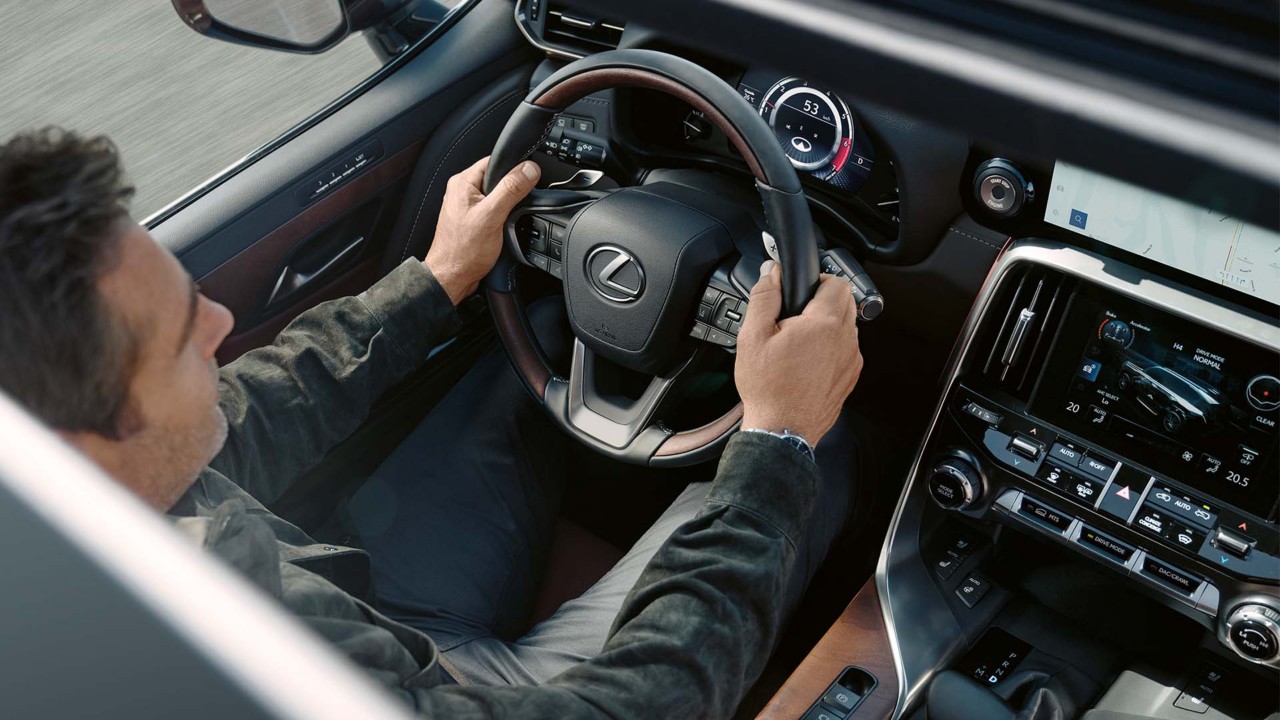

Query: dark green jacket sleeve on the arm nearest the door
<box><xmin>210</xmin><ymin>258</ymin><xmax>460</xmax><ymax>503</ymax></box>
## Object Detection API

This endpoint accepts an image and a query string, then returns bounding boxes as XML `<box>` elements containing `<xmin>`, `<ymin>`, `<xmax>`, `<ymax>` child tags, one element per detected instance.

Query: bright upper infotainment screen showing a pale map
<box><xmin>1044</xmin><ymin>161</ymin><xmax>1280</xmax><ymax>305</ymax></box>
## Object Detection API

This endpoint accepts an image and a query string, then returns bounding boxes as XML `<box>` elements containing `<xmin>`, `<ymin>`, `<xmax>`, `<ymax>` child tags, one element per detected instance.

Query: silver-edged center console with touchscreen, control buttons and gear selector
<box><xmin>764</xmin><ymin>241</ymin><xmax>1280</xmax><ymax>720</ymax></box>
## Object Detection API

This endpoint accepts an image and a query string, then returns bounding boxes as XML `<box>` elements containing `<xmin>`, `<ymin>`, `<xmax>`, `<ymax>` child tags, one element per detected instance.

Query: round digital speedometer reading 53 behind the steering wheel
<box><xmin>739</xmin><ymin>72</ymin><xmax>874</xmax><ymax>191</ymax></box>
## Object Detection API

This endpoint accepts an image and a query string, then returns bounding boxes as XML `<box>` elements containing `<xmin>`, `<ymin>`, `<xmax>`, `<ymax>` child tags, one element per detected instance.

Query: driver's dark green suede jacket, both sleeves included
<box><xmin>170</xmin><ymin>259</ymin><xmax>818</xmax><ymax>720</ymax></box>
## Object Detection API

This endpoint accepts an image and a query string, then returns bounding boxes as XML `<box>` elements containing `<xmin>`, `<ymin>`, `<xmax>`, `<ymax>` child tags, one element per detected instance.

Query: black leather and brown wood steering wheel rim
<box><xmin>484</xmin><ymin>50</ymin><xmax>819</xmax><ymax>466</ymax></box>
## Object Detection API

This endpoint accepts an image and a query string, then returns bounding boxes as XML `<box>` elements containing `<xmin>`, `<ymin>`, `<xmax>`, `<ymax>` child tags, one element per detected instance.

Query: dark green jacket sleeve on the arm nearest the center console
<box><xmin>402</xmin><ymin>433</ymin><xmax>818</xmax><ymax>720</ymax></box>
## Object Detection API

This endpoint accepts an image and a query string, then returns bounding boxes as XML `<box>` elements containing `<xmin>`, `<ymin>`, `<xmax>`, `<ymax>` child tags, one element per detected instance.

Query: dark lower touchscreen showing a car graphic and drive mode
<box><xmin>1032</xmin><ymin>284</ymin><xmax>1280</xmax><ymax>519</ymax></box>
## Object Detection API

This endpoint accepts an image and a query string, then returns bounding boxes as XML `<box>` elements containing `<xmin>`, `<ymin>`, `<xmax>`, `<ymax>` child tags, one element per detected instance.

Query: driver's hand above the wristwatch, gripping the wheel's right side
<box><xmin>733</xmin><ymin>260</ymin><xmax>863</xmax><ymax>446</ymax></box>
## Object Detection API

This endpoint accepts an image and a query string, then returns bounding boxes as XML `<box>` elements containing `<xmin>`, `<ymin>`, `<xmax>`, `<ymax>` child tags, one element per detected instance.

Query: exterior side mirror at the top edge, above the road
<box><xmin>173</xmin><ymin>0</ymin><xmax>349</xmax><ymax>53</ymax></box>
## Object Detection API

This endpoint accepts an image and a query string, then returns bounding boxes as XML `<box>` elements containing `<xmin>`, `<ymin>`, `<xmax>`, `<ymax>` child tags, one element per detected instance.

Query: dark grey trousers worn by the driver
<box><xmin>349</xmin><ymin>302</ymin><xmax>861</xmax><ymax>685</ymax></box>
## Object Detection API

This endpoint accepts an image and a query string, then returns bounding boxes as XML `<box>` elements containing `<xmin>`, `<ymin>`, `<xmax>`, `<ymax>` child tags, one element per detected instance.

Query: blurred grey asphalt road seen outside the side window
<box><xmin>0</xmin><ymin>0</ymin><xmax>379</xmax><ymax>219</ymax></box>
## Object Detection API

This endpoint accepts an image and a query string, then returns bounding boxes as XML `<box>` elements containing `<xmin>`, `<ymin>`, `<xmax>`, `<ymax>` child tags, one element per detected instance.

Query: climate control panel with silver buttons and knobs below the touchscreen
<box><xmin>922</xmin><ymin>383</ymin><xmax>1280</xmax><ymax>666</ymax></box>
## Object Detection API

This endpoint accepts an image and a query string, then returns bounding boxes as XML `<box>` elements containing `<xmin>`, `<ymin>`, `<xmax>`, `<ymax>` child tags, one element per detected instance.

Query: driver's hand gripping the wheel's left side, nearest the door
<box><xmin>424</xmin><ymin>158</ymin><xmax>541</xmax><ymax>305</ymax></box>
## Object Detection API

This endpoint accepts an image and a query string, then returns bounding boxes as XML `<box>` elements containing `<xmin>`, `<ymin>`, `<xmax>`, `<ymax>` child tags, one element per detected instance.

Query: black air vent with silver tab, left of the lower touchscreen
<box><xmin>977</xmin><ymin>266</ymin><xmax>1074</xmax><ymax>401</ymax></box>
